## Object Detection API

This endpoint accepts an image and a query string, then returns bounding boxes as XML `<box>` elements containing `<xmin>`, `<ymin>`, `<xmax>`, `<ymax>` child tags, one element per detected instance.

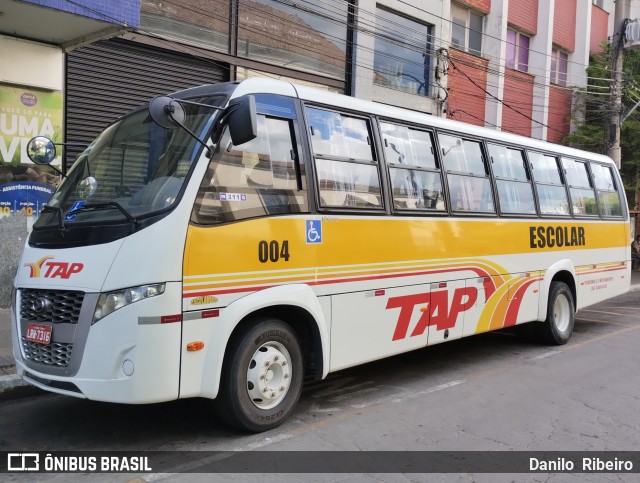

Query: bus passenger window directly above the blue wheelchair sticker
<box><xmin>306</xmin><ymin>107</ymin><xmax>382</xmax><ymax>208</ymax></box>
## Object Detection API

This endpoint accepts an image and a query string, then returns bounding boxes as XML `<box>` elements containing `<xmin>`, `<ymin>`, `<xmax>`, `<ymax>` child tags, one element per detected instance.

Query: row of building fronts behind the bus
<box><xmin>0</xmin><ymin>0</ymin><xmax>636</xmax><ymax>305</ymax></box>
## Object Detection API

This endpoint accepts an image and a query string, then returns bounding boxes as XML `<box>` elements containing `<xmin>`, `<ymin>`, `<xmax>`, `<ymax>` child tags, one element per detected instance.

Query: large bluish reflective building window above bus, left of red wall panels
<box><xmin>373</xmin><ymin>7</ymin><xmax>434</xmax><ymax>96</ymax></box>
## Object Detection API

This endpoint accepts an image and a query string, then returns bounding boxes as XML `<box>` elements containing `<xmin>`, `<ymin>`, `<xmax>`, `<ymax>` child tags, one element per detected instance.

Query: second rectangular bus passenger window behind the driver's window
<box><xmin>380</xmin><ymin>122</ymin><xmax>445</xmax><ymax>211</ymax></box>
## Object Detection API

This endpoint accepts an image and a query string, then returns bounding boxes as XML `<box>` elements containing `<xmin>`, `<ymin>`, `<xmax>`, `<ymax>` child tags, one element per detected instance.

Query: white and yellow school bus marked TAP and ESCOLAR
<box><xmin>13</xmin><ymin>79</ymin><xmax>631</xmax><ymax>431</ymax></box>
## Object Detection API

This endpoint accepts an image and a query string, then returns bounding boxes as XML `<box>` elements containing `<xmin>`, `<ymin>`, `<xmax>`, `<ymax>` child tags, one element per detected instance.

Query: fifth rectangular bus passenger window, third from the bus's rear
<box><xmin>527</xmin><ymin>151</ymin><xmax>569</xmax><ymax>216</ymax></box>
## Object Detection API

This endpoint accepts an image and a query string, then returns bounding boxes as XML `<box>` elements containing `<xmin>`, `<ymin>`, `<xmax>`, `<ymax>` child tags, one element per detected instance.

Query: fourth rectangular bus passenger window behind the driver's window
<box><xmin>489</xmin><ymin>144</ymin><xmax>536</xmax><ymax>214</ymax></box>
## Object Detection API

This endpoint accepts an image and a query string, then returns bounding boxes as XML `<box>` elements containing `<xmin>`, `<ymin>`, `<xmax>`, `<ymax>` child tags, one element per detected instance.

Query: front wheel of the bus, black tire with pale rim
<box><xmin>215</xmin><ymin>319</ymin><xmax>304</xmax><ymax>433</ymax></box>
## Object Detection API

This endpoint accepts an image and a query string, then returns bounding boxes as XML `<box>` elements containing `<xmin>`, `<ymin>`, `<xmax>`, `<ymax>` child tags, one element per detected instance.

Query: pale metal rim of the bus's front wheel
<box><xmin>247</xmin><ymin>341</ymin><xmax>291</xmax><ymax>409</ymax></box>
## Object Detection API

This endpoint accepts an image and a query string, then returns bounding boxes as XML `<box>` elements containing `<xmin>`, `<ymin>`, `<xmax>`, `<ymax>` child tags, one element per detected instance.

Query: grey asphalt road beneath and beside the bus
<box><xmin>0</xmin><ymin>292</ymin><xmax>640</xmax><ymax>482</ymax></box>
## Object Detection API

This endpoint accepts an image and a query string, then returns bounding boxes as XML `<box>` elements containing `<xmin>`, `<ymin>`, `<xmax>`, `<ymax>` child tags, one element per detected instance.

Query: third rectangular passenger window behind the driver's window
<box><xmin>438</xmin><ymin>134</ymin><xmax>495</xmax><ymax>213</ymax></box>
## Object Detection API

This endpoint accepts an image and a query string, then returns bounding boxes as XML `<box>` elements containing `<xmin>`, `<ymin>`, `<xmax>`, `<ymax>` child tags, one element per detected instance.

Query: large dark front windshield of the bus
<box><xmin>34</xmin><ymin>96</ymin><xmax>226</xmax><ymax>229</ymax></box>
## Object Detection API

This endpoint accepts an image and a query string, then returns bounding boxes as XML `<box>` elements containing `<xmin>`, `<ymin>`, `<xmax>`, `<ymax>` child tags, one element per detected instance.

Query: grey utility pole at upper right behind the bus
<box><xmin>606</xmin><ymin>0</ymin><xmax>626</xmax><ymax>168</ymax></box>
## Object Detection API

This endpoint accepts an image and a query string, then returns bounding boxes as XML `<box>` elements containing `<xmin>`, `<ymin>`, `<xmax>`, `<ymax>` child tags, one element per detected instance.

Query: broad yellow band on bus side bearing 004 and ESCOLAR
<box><xmin>184</xmin><ymin>217</ymin><xmax>628</xmax><ymax>281</ymax></box>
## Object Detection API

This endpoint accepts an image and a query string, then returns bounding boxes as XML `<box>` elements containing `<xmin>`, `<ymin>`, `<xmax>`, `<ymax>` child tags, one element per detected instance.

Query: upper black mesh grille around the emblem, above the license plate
<box><xmin>20</xmin><ymin>289</ymin><xmax>84</xmax><ymax>324</ymax></box>
